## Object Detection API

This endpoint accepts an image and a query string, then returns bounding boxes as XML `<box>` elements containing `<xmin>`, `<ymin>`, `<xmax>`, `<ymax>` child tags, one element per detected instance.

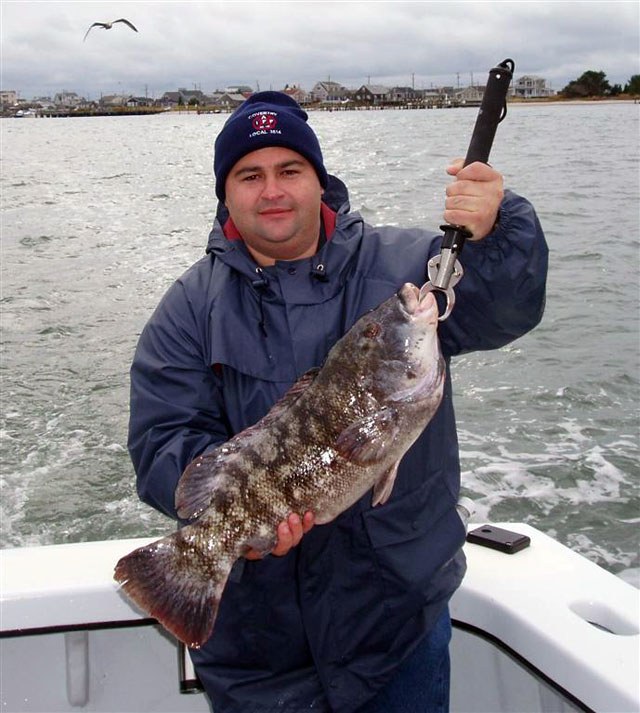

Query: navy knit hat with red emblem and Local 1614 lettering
<box><xmin>213</xmin><ymin>92</ymin><xmax>328</xmax><ymax>201</ymax></box>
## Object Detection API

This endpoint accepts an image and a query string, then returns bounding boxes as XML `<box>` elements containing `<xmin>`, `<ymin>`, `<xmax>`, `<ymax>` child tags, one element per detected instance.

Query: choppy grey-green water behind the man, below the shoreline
<box><xmin>0</xmin><ymin>104</ymin><xmax>640</xmax><ymax>580</ymax></box>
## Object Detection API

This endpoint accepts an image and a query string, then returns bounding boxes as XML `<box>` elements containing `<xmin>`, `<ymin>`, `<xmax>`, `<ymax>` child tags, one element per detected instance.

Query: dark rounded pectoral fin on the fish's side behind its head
<box><xmin>335</xmin><ymin>406</ymin><xmax>398</xmax><ymax>465</ymax></box>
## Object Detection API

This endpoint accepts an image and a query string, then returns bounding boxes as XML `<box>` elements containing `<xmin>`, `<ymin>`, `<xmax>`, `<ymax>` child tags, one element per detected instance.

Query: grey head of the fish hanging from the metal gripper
<box><xmin>342</xmin><ymin>283</ymin><xmax>445</xmax><ymax>404</ymax></box>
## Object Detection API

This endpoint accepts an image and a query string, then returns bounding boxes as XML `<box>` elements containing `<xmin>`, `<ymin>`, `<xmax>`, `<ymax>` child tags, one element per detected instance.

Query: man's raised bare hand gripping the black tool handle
<box><xmin>443</xmin><ymin>159</ymin><xmax>504</xmax><ymax>240</ymax></box>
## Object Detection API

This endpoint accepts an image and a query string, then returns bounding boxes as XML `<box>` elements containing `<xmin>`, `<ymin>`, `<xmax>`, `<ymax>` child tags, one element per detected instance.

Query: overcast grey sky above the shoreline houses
<box><xmin>0</xmin><ymin>0</ymin><xmax>640</xmax><ymax>99</ymax></box>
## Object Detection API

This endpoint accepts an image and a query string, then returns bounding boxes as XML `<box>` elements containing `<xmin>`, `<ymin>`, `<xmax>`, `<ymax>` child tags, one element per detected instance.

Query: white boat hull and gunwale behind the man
<box><xmin>0</xmin><ymin>524</ymin><xmax>640</xmax><ymax>713</ymax></box>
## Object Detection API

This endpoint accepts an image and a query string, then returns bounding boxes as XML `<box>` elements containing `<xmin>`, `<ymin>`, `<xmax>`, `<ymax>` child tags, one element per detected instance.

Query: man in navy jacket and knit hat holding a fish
<box><xmin>129</xmin><ymin>92</ymin><xmax>547</xmax><ymax>713</ymax></box>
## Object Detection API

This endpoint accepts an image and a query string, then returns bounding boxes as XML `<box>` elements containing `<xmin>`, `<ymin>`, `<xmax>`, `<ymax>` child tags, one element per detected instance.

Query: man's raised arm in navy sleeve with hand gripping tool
<box><xmin>438</xmin><ymin>162</ymin><xmax>548</xmax><ymax>355</ymax></box>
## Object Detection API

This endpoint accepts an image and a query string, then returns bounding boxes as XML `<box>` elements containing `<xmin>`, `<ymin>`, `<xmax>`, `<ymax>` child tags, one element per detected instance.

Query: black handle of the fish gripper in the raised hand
<box><xmin>440</xmin><ymin>59</ymin><xmax>515</xmax><ymax>254</ymax></box>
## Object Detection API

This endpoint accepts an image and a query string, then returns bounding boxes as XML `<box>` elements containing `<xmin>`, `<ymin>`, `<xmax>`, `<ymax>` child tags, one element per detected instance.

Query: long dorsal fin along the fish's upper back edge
<box><xmin>175</xmin><ymin>368</ymin><xmax>320</xmax><ymax>520</ymax></box>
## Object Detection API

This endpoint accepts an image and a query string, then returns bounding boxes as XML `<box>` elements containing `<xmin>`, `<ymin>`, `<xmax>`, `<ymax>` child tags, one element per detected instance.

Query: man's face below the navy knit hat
<box><xmin>225</xmin><ymin>146</ymin><xmax>323</xmax><ymax>265</ymax></box>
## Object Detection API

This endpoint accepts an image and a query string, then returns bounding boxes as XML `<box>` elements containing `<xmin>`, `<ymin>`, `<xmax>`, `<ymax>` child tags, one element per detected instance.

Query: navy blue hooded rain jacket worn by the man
<box><xmin>129</xmin><ymin>178</ymin><xmax>547</xmax><ymax>713</ymax></box>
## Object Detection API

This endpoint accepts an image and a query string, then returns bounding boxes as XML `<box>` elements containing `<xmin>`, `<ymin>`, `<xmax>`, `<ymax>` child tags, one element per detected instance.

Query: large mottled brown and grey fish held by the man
<box><xmin>115</xmin><ymin>283</ymin><xmax>445</xmax><ymax>647</ymax></box>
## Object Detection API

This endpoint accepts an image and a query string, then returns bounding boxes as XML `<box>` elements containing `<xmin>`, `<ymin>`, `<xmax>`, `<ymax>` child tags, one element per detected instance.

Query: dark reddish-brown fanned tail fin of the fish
<box><xmin>114</xmin><ymin>526</ymin><xmax>233</xmax><ymax>648</ymax></box>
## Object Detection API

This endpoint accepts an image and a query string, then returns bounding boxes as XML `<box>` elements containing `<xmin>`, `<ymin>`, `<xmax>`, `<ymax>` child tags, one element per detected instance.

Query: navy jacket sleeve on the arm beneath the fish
<box><xmin>128</xmin><ymin>282</ymin><xmax>230</xmax><ymax>519</ymax></box>
